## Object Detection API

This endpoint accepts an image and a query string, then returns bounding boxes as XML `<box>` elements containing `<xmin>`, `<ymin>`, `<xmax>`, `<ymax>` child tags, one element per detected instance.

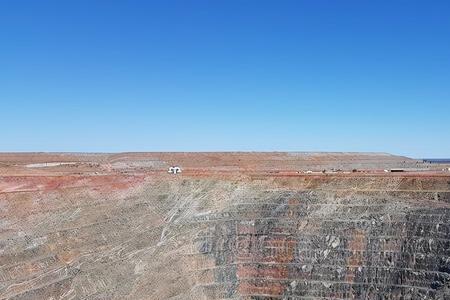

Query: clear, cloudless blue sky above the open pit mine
<box><xmin>0</xmin><ymin>0</ymin><xmax>450</xmax><ymax>157</ymax></box>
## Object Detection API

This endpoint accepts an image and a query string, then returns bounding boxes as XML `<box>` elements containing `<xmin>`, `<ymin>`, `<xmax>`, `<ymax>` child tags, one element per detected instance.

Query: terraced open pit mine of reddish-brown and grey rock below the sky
<box><xmin>0</xmin><ymin>153</ymin><xmax>450</xmax><ymax>300</ymax></box>
